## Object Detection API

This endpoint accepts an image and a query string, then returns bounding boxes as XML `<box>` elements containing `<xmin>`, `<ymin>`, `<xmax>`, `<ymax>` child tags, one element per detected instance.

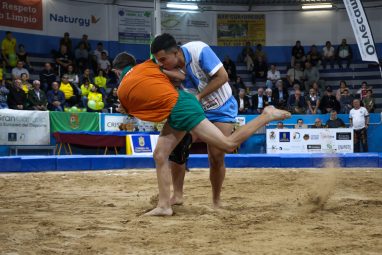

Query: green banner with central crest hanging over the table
<box><xmin>49</xmin><ymin>112</ymin><xmax>100</xmax><ymax>133</ymax></box>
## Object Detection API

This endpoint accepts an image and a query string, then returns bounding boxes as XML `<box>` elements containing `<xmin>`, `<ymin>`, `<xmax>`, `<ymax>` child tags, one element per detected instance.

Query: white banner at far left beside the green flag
<box><xmin>0</xmin><ymin>109</ymin><xmax>50</xmax><ymax>145</ymax></box>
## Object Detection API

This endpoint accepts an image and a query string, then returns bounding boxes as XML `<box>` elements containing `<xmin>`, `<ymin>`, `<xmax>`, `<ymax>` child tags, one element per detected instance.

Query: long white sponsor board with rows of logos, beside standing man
<box><xmin>267</xmin><ymin>128</ymin><xmax>353</xmax><ymax>154</ymax></box>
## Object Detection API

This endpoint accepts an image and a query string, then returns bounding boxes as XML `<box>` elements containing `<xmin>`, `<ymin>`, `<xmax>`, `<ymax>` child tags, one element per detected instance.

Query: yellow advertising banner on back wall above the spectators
<box><xmin>217</xmin><ymin>14</ymin><xmax>266</xmax><ymax>46</ymax></box>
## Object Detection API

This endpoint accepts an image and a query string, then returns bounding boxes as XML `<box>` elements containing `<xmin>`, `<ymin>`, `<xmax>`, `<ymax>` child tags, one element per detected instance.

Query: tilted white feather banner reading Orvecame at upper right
<box><xmin>344</xmin><ymin>0</ymin><xmax>379</xmax><ymax>63</ymax></box>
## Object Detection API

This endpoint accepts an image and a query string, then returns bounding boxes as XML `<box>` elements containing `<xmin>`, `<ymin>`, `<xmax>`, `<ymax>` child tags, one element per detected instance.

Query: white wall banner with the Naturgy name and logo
<box><xmin>44</xmin><ymin>1</ymin><xmax>110</xmax><ymax>39</ymax></box>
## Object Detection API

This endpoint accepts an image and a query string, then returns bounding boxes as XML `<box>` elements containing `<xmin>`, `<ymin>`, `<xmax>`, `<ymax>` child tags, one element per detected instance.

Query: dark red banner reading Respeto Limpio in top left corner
<box><xmin>0</xmin><ymin>0</ymin><xmax>43</xmax><ymax>30</ymax></box>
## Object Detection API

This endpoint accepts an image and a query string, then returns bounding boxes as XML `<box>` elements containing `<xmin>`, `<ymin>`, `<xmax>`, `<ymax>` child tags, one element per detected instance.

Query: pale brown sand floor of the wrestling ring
<box><xmin>0</xmin><ymin>169</ymin><xmax>382</xmax><ymax>255</ymax></box>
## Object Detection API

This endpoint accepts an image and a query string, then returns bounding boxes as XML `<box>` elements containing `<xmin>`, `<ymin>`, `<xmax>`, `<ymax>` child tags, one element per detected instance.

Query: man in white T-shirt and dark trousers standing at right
<box><xmin>349</xmin><ymin>99</ymin><xmax>369</xmax><ymax>152</ymax></box>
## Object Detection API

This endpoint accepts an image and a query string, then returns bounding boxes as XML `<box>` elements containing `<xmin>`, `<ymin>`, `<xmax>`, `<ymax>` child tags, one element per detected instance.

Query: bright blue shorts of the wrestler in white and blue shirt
<box><xmin>205</xmin><ymin>96</ymin><xmax>238</xmax><ymax>123</ymax></box>
